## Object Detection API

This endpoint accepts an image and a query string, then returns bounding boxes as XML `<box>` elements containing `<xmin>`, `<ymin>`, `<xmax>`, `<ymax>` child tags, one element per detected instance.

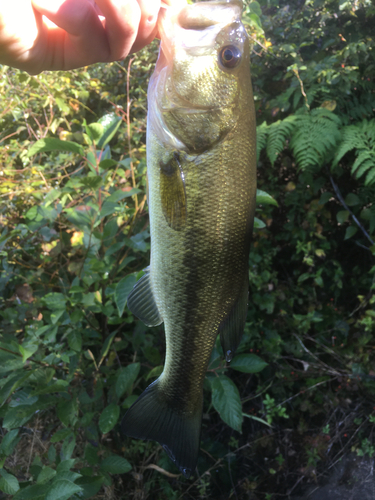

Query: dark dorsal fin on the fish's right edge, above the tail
<box><xmin>219</xmin><ymin>276</ymin><xmax>249</xmax><ymax>362</ymax></box>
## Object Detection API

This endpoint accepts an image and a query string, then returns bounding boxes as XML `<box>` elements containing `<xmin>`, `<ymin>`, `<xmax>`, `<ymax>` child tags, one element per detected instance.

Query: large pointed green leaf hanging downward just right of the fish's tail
<box><xmin>211</xmin><ymin>375</ymin><xmax>242</xmax><ymax>432</ymax></box>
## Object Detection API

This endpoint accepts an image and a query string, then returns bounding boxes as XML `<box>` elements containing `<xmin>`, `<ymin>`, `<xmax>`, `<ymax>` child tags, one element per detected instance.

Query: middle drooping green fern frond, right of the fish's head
<box><xmin>290</xmin><ymin>108</ymin><xmax>341</xmax><ymax>169</ymax></box>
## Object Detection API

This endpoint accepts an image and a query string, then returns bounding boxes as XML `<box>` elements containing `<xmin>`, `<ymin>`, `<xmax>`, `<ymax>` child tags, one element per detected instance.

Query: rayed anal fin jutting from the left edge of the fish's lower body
<box><xmin>128</xmin><ymin>267</ymin><xmax>163</xmax><ymax>326</ymax></box>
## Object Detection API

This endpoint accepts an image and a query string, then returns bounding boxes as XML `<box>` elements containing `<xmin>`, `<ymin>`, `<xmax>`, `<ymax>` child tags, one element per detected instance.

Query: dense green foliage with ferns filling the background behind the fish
<box><xmin>0</xmin><ymin>0</ymin><xmax>375</xmax><ymax>500</ymax></box>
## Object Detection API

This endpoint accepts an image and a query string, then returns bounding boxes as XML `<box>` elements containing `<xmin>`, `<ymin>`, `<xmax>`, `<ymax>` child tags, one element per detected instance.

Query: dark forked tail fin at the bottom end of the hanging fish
<box><xmin>121</xmin><ymin>379</ymin><xmax>203</xmax><ymax>478</ymax></box>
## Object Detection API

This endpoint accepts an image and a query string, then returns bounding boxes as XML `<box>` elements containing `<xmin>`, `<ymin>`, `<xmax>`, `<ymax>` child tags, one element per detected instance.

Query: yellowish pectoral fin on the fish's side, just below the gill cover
<box><xmin>160</xmin><ymin>153</ymin><xmax>186</xmax><ymax>231</ymax></box>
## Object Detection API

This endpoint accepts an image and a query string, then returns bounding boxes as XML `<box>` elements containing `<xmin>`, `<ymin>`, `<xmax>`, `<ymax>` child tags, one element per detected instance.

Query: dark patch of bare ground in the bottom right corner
<box><xmin>291</xmin><ymin>454</ymin><xmax>375</xmax><ymax>500</ymax></box>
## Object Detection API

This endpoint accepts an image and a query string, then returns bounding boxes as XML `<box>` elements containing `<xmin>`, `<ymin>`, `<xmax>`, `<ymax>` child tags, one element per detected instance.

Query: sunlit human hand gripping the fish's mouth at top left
<box><xmin>0</xmin><ymin>0</ymin><xmax>163</xmax><ymax>74</ymax></box>
